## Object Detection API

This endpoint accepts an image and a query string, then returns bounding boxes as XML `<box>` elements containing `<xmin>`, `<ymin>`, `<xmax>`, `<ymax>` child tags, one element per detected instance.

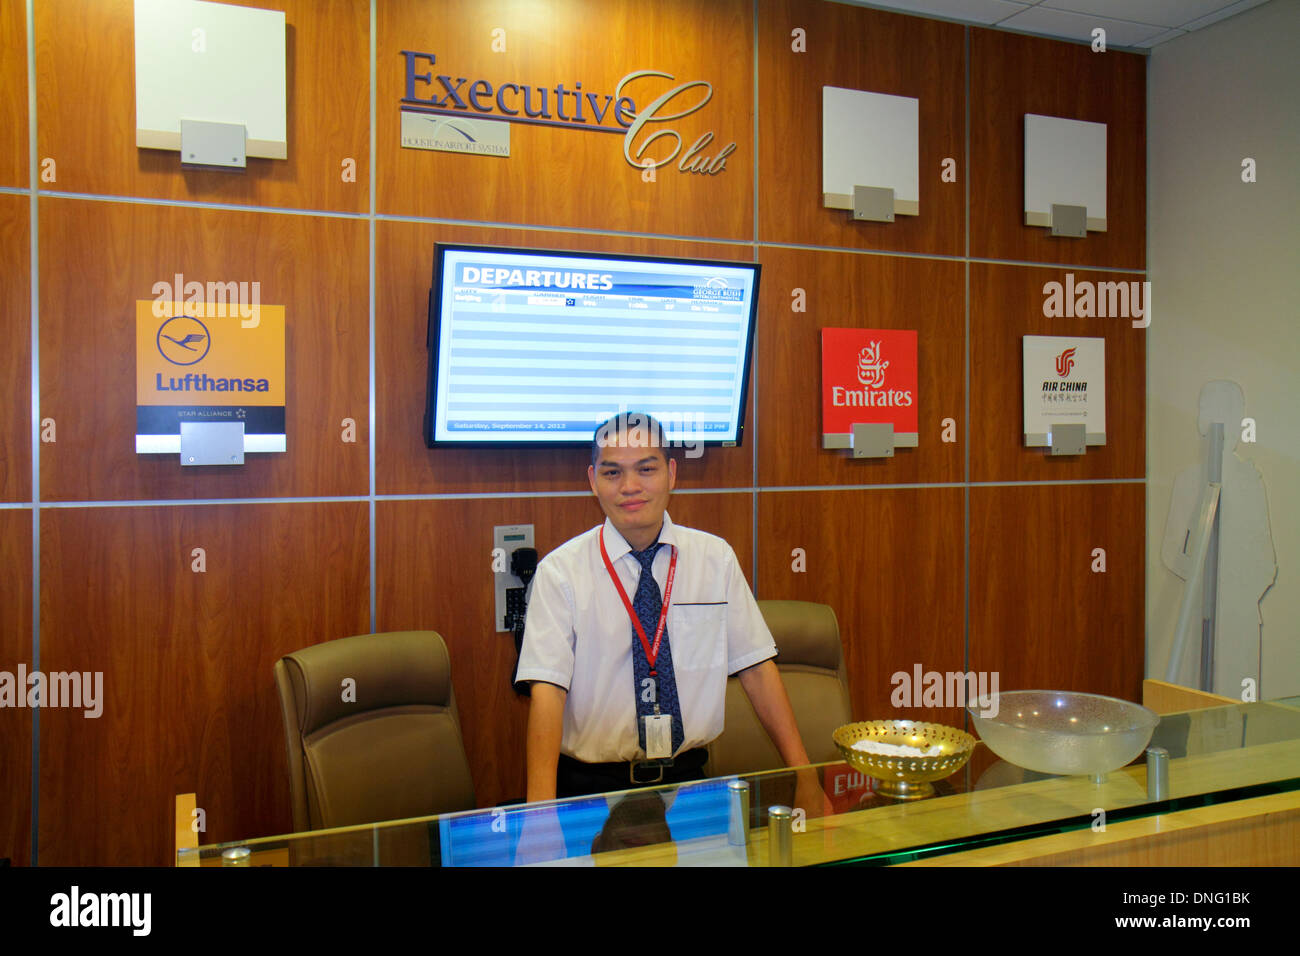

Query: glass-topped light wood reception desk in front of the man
<box><xmin>177</xmin><ymin>698</ymin><xmax>1300</xmax><ymax>866</ymax></box>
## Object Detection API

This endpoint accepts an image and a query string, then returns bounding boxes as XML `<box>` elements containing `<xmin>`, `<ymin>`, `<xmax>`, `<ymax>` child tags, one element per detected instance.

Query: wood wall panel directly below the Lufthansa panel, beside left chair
<box><xmin>38</xmin><ymin>501</ymin><xmax>371</xmax><ymax>865</ymax></box>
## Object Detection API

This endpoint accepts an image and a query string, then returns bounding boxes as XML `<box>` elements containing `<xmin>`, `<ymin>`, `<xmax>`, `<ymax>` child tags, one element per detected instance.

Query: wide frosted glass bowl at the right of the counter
<box><xmin>966</xmin><ymin>691</ymin><xmax>1160</xmax><ymax>783</ymax></box>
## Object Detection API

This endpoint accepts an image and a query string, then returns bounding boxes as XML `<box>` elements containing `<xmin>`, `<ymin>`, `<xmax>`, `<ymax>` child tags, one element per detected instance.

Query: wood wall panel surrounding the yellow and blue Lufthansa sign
<box><xmin>39</xmin><ymin>196</ymin><xmax>369</xmax><ymax>501</ymax></box>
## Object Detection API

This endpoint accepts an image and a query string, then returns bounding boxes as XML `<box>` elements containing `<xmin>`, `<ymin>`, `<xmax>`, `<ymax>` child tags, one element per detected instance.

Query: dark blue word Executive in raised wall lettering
<box><xmin>402</xmin><ymin>49</ymin><xmax>637</xmax><ymax>129</ymax></box>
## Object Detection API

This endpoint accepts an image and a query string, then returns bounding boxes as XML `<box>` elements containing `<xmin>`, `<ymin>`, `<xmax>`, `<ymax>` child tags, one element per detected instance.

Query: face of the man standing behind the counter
<box><xmin>586</xmin><ymin>445</ymin><xmax>677</xmax><ymax>550</ymax></box>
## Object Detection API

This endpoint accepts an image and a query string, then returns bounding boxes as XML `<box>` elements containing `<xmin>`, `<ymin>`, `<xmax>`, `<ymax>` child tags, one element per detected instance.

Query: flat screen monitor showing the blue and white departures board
<box><xmin>424</xmin><ymin>243</ymin><xmax>759</xmax><ymax>447</ymax></box>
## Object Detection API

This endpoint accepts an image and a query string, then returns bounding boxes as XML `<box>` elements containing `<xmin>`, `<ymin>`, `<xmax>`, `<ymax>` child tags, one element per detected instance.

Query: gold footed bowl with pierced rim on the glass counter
<box><xmin>831</xmin><ymin>721</ymin><xmax>975</xmax><ymax>800</ymax></box>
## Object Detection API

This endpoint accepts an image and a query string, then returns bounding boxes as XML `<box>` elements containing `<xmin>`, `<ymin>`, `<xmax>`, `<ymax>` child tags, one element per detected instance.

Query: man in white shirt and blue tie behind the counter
<box><xmin>516</xmin><ymin>412</ymin><xmax>809</xmax><ymax>803</ymax></box>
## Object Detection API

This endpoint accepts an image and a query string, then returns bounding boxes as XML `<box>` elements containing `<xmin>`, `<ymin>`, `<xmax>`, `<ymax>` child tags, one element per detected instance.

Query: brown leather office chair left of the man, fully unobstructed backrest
<box><xmin>274</xmin><ymin>631</ymin><xmax>475</xmax><ymax>831</ymax></box>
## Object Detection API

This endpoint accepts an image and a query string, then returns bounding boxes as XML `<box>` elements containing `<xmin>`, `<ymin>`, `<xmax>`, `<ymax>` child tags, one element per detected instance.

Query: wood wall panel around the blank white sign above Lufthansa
<box><xmin>35</xmin><ymin>0</ymin><xmax>371</xmax><ymax>212</ymax></box>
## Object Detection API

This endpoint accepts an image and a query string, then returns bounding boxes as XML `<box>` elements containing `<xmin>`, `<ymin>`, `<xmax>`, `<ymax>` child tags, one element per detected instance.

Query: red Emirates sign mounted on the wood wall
<box><xmin>822</xmin><ymin>329</ymin><xmax>918</xmax><ymax>447</ymax></box>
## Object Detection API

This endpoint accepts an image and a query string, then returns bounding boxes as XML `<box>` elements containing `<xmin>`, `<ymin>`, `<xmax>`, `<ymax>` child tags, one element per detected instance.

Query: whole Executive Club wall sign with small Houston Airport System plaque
<box><xmin>402</xmin><ymin>49</ymin><xmax>736</xmax><ymax>176</ymax></box>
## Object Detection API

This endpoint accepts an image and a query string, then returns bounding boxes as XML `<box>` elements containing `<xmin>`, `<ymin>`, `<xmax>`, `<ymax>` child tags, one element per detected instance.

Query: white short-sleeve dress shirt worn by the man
<box><xmin>516</xmin><ymin>514</ymin><xmax>776</xmax><ymax>763</ymax></box>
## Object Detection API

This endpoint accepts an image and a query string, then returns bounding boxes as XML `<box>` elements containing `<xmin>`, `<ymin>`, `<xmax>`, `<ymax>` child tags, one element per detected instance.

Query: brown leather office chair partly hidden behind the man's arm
<box><xmin>705</xmin><ymin>601</ymin><xmax>853</xmax><ymax>777</ymax></box>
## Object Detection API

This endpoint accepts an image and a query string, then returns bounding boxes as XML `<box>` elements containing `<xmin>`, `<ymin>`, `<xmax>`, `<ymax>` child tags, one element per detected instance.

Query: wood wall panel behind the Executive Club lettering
<box><xmin>376</xmin><ymin>0</ymin><xmax>754</xmax><ymax>239</ymax></box>
